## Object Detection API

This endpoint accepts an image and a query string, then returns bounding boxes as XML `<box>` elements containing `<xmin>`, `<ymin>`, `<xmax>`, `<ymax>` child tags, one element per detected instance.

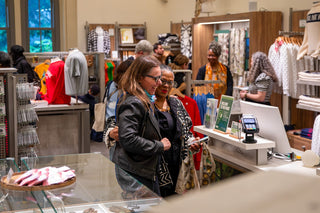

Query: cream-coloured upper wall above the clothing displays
<box><xmin>77</xmin><ymin>0</ymin><xmax>314</xmax><ymax>51</ymax></box>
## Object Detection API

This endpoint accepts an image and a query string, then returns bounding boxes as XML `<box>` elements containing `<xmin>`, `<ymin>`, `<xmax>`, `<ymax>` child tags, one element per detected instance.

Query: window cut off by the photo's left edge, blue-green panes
<box><xmin>0</xmin><ymin>0</ymin><xmax>14</xmax><ymax>52</ymax></box>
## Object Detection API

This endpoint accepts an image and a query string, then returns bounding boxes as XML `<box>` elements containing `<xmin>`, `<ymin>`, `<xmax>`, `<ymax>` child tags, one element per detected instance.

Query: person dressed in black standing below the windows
<box><xmin>10</xmin><ymin>45</ymin><xmax>39</xmax><ymax>83</ymax></box>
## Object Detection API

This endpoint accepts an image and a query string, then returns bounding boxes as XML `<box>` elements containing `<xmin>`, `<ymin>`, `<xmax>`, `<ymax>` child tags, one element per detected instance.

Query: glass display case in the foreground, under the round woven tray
<box><xmin>0</xmin><ymin>153</ymin><xmax>162</xmax><ymax>213</ymax></box>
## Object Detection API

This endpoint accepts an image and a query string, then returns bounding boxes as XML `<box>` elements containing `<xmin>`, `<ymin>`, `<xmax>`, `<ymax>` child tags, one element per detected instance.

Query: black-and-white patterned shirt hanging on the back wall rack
<box><xmin>88</xmin><ymin>29</ymin><xmax>111</xmax><ymax>58</ymax></box>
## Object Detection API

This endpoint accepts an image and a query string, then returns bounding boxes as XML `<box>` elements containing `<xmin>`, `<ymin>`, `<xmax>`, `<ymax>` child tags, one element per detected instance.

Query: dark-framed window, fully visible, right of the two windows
<box><xmin>21</xmin><ymin>0</ymin><xmax>59</xmax><ymax>52</ymax></box>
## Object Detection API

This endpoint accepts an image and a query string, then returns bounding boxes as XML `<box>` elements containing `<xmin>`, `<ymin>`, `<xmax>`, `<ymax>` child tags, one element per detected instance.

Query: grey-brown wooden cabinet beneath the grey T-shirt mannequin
<box><xmin>35</xmin><ymin>104</ymin><xmax>90</xmax><ymax>156</ymax></box>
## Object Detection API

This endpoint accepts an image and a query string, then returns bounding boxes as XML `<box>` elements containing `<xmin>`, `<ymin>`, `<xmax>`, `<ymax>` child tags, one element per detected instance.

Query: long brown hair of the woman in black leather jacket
<box><xmin>118</xmin><ymin>55</ymin><xmax>160</xmax><ymax>108</ymax></box>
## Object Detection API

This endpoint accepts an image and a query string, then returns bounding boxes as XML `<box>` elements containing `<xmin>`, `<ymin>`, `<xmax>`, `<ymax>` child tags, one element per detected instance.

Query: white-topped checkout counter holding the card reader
<box><xmin>194</xmin><ymin>126</ymin><xmax>319</xmax><ymax>176</ymax></box>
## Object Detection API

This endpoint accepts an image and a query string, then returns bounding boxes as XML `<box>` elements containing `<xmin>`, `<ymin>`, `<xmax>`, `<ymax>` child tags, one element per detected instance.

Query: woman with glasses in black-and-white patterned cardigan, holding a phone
<box><xmin>154</xmin><ymin>65</ymin><xmax>200</xmax><ymax>197</ymax></box>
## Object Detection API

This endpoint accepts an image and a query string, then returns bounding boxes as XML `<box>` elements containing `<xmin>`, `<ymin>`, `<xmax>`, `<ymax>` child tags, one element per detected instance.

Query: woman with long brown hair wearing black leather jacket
<box><xmin>112</xmin><ymin>56</ymin><xmax>171</xmax><ymax>194</ymax></box>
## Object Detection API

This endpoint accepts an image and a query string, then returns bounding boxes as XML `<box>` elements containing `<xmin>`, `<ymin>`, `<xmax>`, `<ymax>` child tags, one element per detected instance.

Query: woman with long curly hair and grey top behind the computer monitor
<box><xmin>240</xmin><ymin>52</ymin><xmax>278</xmax><ymax>105</ymax></box>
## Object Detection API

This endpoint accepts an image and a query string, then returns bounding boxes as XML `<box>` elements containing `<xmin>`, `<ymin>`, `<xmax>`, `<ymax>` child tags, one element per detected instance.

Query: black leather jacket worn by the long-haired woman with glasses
<box><xmin>112</xmin><ymin>95</ymin><xmax>163</xmax><ymax>180</ymax></box>
